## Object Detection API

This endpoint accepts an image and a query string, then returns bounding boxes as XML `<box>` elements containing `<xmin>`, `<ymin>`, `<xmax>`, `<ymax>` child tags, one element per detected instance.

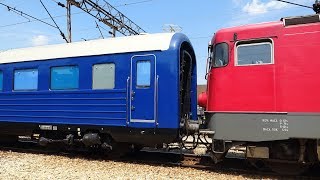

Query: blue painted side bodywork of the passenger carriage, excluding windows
<box><xmin>0</xmin><ymin>34</ymin><xmax>197</xmax><ymax>132</ymax></box>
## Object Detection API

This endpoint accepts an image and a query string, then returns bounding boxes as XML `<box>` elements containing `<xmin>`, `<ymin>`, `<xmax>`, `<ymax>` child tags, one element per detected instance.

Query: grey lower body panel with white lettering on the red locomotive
<box><xmin>207</xmin><ymin>113</ymin><xmax>320</xmax><ymax>142</ymax></box>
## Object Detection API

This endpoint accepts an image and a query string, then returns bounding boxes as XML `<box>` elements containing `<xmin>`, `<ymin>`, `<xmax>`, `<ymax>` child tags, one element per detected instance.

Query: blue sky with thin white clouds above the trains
<box><xmin>0</xmin><ymin>0</ymin><xmax>314</xmax><ymax>84</ymax></box>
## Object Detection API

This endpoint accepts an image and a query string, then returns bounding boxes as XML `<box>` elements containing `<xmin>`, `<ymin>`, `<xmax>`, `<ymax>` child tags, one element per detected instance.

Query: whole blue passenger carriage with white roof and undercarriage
<box><xmin>0</xmin><ymin>33</ymin><xmax>197</xmax><ymax>149</ymax></box>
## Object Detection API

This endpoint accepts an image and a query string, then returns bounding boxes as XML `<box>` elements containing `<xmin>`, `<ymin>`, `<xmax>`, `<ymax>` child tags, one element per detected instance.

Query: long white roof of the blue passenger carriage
<box><xmin>0</xmin><ymin>33</ymin><xmax>174</xmax><ymax>64</ymax></box>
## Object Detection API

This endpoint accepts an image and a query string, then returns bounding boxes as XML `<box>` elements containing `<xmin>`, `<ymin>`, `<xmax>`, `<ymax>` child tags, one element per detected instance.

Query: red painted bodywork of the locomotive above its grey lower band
<box><xmin>206</xmin><ymin>21</ymin><xmax>320</xmax><ymax>112</ymax></box>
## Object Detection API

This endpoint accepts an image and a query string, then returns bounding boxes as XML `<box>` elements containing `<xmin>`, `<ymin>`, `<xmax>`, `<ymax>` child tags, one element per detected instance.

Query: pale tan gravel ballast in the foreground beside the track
<box><xmin>0</xmin><ymin>151</ymin><xmax>272</xmax><ymax>180</ymax></box>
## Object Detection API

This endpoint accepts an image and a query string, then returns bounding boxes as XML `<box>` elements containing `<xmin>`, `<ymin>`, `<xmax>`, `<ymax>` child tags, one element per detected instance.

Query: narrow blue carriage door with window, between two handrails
<box><xmin>130</xmin><ymin>55</ymin><xmax>156</xmax><ymax>127</ymax></box>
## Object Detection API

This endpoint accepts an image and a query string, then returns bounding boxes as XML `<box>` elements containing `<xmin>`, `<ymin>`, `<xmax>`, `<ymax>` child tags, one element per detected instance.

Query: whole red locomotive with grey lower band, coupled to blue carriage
<box><xmin>199</xmin><ymin>14</ymin><xmax>320</xmax><ymax>173</ymax></box>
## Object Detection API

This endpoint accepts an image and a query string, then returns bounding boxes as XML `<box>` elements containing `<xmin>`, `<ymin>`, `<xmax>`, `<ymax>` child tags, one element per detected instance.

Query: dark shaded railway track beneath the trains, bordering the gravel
<box><xmin>0</xmin><ymin>143</ymin><xmax>320</xmax><ymax>179</ymax></box>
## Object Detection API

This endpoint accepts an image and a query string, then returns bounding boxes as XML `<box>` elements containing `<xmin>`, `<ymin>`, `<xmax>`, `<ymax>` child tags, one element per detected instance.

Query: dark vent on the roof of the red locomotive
<box><xmin>281</xmin><ymin>14</ymin><xmax>320</xmax><ymax>26</ymax></box>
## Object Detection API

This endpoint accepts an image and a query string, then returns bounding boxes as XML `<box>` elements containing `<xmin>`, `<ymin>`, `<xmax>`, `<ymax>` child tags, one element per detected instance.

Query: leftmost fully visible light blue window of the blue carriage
<box><xmin>14</xmin><ymin>69</ymin><xmax>38</xmax><ymax>91</ymax></box>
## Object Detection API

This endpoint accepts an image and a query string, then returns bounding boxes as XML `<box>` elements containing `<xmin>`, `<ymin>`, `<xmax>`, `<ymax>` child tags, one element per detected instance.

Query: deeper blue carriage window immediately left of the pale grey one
<box><xmin>51</xmin><ymin>66</ymin><xmax>79</xmax><ymax>90</ymax></box>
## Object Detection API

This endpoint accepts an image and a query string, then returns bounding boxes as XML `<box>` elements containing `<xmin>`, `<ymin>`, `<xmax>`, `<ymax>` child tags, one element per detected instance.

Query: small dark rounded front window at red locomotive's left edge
<box><xmin>211</xmin><ymin>43</ymin><xmax>229</xmax><ymax>67</ymax></box>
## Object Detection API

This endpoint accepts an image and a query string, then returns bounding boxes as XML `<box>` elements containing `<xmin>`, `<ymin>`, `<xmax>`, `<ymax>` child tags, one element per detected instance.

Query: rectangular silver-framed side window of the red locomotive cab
<box><xmin>236</xmin><ymin>42</ymin><xmax>273</xmax><ymax>66</ymax></box>
